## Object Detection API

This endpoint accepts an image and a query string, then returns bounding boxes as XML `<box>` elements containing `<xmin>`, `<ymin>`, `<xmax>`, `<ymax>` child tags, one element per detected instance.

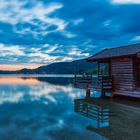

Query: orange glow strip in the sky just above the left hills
<box><xmin>0</xmin><ymin>64</ymin><xmax>42</xmax><ymax>71</ymax></box>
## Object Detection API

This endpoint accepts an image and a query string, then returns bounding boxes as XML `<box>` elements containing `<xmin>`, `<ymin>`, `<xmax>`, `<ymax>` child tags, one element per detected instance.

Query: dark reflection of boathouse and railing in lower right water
<box><xmin>74</xmin><ymin>96</ymin><xmax>140</xmax><ymax>140</ymax></box>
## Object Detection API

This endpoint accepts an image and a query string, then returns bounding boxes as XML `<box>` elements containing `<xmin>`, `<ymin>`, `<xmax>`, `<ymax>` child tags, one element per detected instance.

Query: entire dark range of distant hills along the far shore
<box><xmin>0</xmin><ymin>59</ymin><xmax>97</xmax><ymax>74</ymax></box>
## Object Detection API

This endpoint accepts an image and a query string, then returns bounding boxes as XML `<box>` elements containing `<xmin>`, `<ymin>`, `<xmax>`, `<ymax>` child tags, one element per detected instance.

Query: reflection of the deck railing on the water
<box><xmin>74</xmin><ymin>99</ymin><xmax>109</xmax><ymax>128</ymax></box>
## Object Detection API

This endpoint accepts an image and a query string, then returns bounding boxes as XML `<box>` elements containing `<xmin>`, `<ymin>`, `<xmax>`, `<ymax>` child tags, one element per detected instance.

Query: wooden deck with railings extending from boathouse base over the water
<box><xmin>74</xmin><ymin>75</ymin><xmax>140</xmax><ymax>98</ymax></box>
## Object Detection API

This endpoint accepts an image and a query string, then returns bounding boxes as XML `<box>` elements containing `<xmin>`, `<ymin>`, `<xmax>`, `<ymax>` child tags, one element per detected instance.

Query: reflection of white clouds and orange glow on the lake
<box><xmin>0</xmin><ymin>77</ymin><xmax>84</xmax><ymax>105</ymax></box>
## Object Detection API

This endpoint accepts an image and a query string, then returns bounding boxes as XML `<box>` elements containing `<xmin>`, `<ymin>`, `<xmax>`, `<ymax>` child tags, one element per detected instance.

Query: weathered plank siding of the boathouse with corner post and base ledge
<box><xmin>111</xmin><ymin>58</ymin><xmax>140</xmax><ymax>97</ymax></box>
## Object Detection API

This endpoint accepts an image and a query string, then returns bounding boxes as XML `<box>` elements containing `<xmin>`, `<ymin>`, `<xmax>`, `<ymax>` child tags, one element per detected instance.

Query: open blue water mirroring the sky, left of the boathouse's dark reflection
<box><xmin>0</xmin><ymin>77</ymin><xmax>105</xmax><ymax>140</ymax></box>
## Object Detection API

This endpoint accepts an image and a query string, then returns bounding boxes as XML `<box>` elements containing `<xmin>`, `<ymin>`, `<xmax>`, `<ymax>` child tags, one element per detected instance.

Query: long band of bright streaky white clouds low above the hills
<box><xmin>0</xmin><ymin>44</ymin><xmax>89</xmax><ymax>65</ymax></box>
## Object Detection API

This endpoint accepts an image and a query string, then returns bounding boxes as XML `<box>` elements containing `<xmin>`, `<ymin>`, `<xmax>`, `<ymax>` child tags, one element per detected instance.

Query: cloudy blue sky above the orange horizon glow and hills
<box><xmin>0</xmin><ymin>0</ymin><xmax>140</xmax><ymax>68</ymax></box>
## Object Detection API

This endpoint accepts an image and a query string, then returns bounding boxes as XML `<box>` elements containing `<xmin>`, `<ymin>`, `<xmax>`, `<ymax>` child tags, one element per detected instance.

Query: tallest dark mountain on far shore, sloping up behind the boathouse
<box><xmin>34</xmin><ymin>59</ymin><xmax>96</xmax><ymax>74</ymax></box>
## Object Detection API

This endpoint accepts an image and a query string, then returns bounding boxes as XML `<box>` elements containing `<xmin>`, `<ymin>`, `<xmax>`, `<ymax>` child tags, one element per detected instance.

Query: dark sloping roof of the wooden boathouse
<box><xmin>87</xmin><ymin>43</ymin><xmax>140</xmax><ymax>61</ymax></box>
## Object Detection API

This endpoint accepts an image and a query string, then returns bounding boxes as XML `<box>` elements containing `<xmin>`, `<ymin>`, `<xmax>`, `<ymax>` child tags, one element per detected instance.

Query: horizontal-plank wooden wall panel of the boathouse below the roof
<box><xmin>111</xmin><ymin>58</ymin><xmax>135</xmax><ymax>91</ymax></box>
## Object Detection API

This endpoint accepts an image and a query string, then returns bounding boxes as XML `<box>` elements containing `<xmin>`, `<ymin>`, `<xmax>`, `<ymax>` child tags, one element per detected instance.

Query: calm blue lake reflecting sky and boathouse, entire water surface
<box><xmin>0</xmin><ymin>75</ymin><xmax>140</xmax><ymax>140</ymax></box>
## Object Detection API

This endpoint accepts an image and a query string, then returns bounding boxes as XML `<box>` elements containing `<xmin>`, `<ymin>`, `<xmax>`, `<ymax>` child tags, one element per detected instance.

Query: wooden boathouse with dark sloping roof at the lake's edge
<box><xmin>87</xmin><ymin>43</ymin><xmax>140</xmax><ymax>98</ymax></box>
